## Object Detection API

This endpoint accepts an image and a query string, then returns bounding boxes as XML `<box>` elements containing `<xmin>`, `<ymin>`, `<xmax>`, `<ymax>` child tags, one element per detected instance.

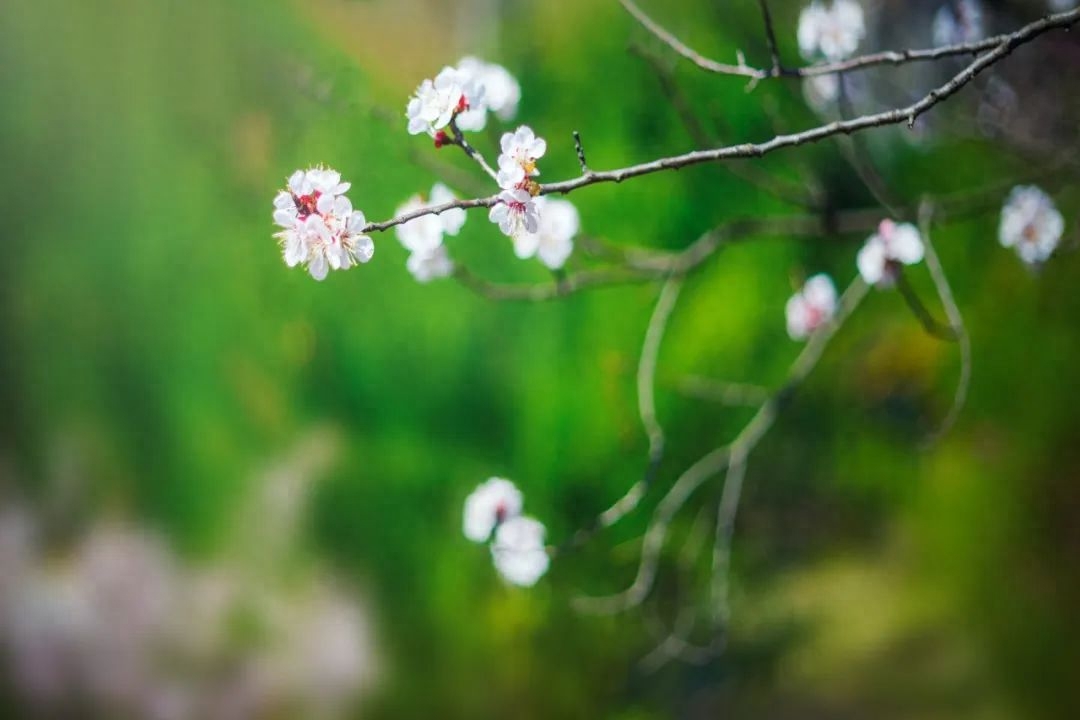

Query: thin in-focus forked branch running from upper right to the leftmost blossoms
<box><xmin>363</xmin><ymin>7</ymin><xmax>1080</xmax><ymax>232</ymax></box>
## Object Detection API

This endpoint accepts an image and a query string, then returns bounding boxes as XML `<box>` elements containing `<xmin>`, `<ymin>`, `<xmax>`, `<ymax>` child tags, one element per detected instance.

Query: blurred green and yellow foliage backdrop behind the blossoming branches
<box><xmin>0</xmin><ymin>0</ymin><xmax>1080</xmax><ymax>720</ymax></box>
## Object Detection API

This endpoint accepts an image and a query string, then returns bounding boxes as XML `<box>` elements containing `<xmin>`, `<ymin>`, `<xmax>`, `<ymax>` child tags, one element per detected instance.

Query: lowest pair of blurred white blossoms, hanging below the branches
<box><xmin>462</xmin><ymin>477</ymin><xmax>551</xmax><ymax>587</ymax></box>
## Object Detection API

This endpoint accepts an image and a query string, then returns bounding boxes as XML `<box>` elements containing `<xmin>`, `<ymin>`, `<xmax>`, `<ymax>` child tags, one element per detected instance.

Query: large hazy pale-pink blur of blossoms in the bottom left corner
<box><xmin>0</xmin><ymin>506</ymin><xmax>374</xmax><ymax>720</ymax></box>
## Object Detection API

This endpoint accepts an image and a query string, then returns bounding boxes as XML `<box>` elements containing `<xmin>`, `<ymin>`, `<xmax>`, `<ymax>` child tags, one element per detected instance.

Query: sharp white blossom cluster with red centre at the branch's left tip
<box><xmin>273</xmin><ymin>167</ymin><xmax>375</xmax><ymax>280</ymax></box>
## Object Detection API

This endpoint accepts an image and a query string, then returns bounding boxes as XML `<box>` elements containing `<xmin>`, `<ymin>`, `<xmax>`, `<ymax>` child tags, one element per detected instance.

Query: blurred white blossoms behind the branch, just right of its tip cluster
<box><xmin>395</xmin><ymin>182</ymin><xmax>465</xmax><ymax>283</ymax></box>
